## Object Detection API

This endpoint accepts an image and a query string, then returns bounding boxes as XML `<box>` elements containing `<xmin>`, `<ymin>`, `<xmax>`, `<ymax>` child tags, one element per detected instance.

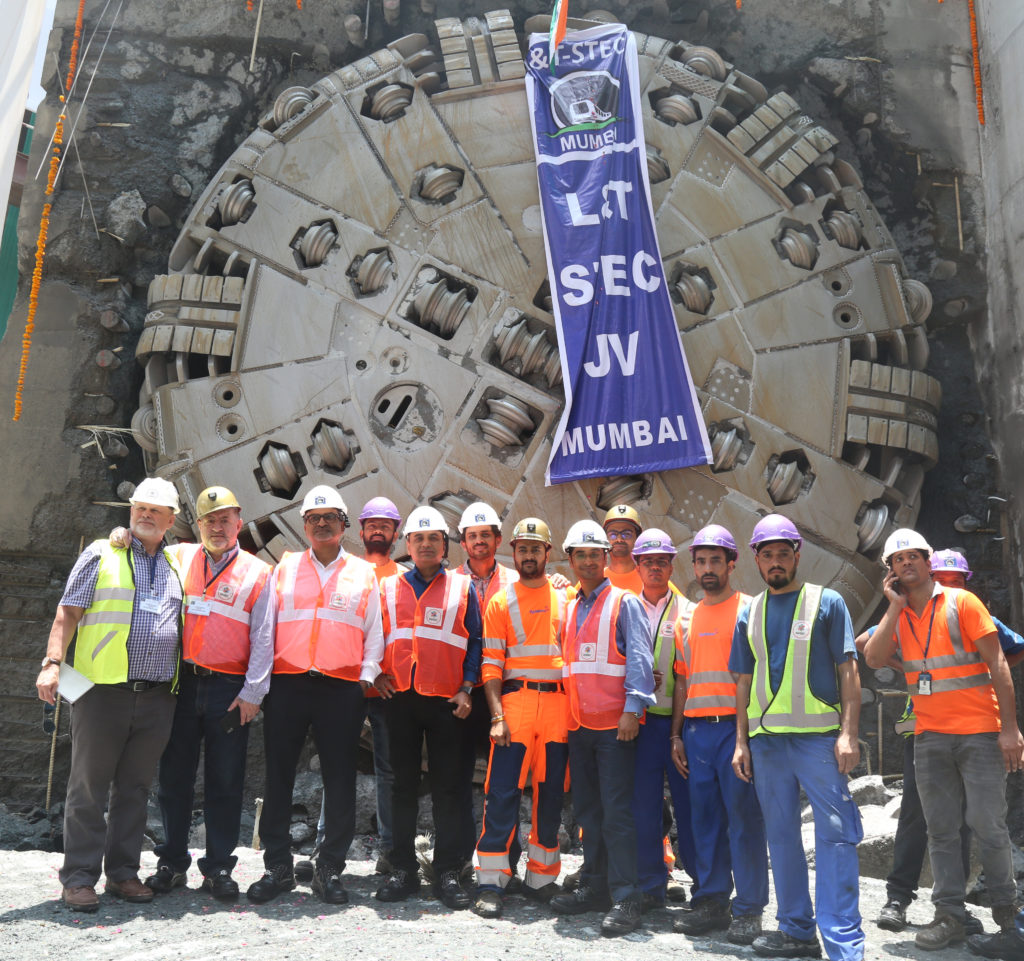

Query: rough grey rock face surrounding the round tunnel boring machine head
<box><xmin>0</xmin><ymin>0</ymin><xmax>1009</xmax><ymax>840</ymax></box>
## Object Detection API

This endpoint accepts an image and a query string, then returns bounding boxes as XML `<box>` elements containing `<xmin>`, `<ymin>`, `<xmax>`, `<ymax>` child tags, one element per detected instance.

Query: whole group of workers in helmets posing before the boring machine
<box><xmin>37</xmin><ymin>477</ymin><xmax>1024</xmax><ymax>961</ymax></box>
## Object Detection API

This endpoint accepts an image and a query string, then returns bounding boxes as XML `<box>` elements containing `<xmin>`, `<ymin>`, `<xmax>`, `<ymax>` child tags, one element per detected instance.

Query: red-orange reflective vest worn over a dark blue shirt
<box><xmin>381</xmin><ymin>569</ymin><xmax>473</xmax><ymax>698</ymax></box>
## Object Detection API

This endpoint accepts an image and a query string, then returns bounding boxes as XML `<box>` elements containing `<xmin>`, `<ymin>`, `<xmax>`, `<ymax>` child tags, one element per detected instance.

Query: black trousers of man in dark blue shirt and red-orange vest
<box><xmin>387</xmin><ymin>691</ymin><xmax>466</xmax><ymax>877</ymax></box>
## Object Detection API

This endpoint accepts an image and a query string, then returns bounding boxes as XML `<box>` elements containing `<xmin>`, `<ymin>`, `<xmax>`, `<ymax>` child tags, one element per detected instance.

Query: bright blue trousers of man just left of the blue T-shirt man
<box><xmin>683</xmin><ymin>717</ymin><xmax>768</xmax><ymax>918</ymax></box>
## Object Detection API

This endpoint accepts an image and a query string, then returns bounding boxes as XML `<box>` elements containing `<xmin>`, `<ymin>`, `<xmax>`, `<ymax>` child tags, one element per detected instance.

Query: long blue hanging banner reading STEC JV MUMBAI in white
<box><xmin>526</xmin><ymin>24</ymin><xmax>711</xmax><ymax>484</ymax></box>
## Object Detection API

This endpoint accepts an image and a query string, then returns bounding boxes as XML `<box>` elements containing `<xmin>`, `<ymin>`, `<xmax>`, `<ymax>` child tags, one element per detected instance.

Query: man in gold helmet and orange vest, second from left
<box><xmin>141</xmin><ymin>487</ymin><xmax>273</xmax><ymax>901</ymax></box>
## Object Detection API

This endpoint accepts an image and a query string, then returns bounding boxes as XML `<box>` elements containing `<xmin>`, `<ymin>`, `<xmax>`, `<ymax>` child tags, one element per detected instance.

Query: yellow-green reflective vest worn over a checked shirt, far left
<box><xmin>70</xmin><ymin>540</ymin><xmax>184</xmax><ymax>691</ymax></box>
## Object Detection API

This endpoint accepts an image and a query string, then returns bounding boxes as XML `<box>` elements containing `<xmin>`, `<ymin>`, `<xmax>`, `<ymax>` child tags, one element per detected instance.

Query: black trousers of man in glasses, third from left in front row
<box><xmin>259</xmin><ymin>674</ymin><xmax>364</xmax><ymax>871</ymax></box>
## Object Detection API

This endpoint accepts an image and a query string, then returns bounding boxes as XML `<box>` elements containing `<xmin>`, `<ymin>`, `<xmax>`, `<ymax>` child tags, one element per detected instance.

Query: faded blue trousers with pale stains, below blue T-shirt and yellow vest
<box><xmin>751</xmin><ymin>734</ymin><xmax>864</xmax><ymax>961</ymax></box>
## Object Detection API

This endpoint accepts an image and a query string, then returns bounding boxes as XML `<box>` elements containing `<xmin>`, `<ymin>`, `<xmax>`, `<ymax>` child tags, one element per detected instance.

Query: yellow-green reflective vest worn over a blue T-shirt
<box><xmin>746</xmin><ymin>584</ymin><xmax>840</xmax><ymax>738</ymax></box>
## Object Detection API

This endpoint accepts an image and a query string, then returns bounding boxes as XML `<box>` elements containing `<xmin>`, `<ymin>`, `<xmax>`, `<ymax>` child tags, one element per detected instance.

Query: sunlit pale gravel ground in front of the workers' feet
<box><xmin>0</xmin><ymin>849</ymin><xmax>995</xmax><ymax>961</ymax></box>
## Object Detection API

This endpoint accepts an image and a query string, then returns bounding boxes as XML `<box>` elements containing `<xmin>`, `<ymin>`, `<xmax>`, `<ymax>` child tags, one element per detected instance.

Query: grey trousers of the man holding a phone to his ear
<box><xmin>913</xmin><ymin>730</ymin><xmax>1017</xmax><ymax>921</ymax></box>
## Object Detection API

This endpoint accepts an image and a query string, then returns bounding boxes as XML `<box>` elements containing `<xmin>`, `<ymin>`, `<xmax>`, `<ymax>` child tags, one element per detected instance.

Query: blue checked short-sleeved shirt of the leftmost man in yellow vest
<box><xmin>60</xmin><ymin>537</ymin><xmax>181</xmax><ymax>681</ymax></box>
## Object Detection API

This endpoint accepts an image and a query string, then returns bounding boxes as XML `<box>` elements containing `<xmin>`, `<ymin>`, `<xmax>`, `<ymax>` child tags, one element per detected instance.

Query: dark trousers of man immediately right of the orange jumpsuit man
<box><xmin>569</xmin><ymin>727</ymin><xmax>634</xmax><ymax>902</ymax></box>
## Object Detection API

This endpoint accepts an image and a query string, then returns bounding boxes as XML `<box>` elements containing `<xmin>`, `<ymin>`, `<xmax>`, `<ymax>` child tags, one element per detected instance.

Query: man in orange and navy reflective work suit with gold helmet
<box><xmin>473</xmin><ymin>517</ymin><xmax>568</xmax><ymax>918</ymax></box>
